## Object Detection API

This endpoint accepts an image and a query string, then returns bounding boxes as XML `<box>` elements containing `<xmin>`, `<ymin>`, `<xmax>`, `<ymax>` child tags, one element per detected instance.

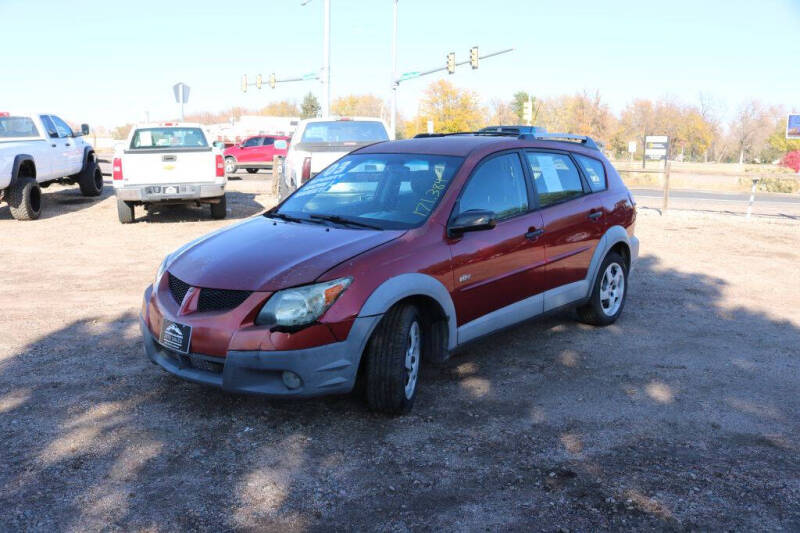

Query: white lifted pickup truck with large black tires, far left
<box><xmin>0</xmin><ymin>112</ymin><xmax>103</xmax><ymax>220</ymax></box>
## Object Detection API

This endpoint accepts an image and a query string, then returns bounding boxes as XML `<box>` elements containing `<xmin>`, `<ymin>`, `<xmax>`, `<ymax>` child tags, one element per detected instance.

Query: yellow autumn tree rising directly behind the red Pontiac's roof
<box><xmin>406</xmin><ymin>80</ymin><xmax>486</xmax><ymax>137</ymax></box>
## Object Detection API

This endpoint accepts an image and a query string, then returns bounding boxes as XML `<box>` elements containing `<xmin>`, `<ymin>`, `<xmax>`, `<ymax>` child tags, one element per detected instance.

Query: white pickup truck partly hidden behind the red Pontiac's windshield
<box><xmin>278</xmin><ymin>117</ymin><xmax>390</xmax><ymax>200</ymax></box>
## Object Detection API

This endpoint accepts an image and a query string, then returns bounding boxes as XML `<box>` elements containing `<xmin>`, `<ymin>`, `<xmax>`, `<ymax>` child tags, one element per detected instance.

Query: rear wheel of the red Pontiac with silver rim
<box><xmin>577</xmin><ymin>252</ymin><xmax>628</xmax><ymax>326</ymax></box>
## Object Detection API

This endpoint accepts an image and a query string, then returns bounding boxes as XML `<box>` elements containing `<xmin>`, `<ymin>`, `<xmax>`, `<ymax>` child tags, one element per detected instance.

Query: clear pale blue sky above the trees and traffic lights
<box><xmin>0</xmin><ymin>0</ymin><xmax>800</xmax><ymax>126</ymax></box>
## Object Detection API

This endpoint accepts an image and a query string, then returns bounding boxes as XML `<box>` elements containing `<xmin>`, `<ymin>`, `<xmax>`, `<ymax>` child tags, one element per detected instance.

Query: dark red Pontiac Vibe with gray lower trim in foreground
<box><xmin>140</xmin><ymin>131</ymin><xmax>639</xmax><ymax>413</ymax></box>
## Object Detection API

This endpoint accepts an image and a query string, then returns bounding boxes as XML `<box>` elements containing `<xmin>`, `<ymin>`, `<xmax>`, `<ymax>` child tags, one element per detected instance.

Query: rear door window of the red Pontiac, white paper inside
<box><xmin>527</xmin><ymin>152</ymin><xmax>583</xmax><ymax>207</ymax></box>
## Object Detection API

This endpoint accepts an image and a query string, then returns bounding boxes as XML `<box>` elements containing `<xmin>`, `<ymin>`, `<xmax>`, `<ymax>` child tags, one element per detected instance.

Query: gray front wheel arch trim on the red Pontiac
<box><xmin>358</xmin><ymin>273</ymin><xmax>458</xmax><ymax>350</ymax></box>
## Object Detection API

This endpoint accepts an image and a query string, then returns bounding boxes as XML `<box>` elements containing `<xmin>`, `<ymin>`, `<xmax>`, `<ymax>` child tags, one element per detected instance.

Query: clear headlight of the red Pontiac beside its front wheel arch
<box><xmin>256</xmin><ymin>278</ymin><xmax>353</xmax><ymax>327</ymax></box>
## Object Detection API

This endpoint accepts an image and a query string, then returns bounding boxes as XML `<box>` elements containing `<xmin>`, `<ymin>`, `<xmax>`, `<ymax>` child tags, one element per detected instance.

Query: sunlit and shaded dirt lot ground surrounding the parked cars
<box><xmin>0</xmin><ymin>180</ymin><xmax>800</xmax><ymax>531</ymax></box>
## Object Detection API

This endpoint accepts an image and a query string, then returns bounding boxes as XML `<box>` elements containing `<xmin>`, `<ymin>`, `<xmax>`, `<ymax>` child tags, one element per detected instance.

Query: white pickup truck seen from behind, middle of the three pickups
<box><xmin>112</xmin><ymin>122</ymin><xmax>227</xmax><ymax>224</ymax></box>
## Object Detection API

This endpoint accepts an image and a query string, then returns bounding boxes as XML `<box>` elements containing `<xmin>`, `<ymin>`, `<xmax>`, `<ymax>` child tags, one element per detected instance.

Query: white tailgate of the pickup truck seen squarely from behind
<box><xmin>122</xmin><ymin>148</ymin><xmax>216</xmax><ymax>185</ymax></box>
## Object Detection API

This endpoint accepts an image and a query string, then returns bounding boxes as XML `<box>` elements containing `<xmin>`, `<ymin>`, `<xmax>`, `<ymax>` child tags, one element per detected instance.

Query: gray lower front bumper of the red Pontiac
<box><xmin>139</xmin><ymin>315</ymin><xmax>381</xmax><ymax>398</ymax></box>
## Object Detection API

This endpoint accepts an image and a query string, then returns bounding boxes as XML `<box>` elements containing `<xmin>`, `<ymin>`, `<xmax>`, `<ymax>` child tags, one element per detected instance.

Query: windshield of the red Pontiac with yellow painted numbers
<box><xmin>278</xmin><ymin>154</ymin><xmax>463</xmax><ymax>229</ymax></box>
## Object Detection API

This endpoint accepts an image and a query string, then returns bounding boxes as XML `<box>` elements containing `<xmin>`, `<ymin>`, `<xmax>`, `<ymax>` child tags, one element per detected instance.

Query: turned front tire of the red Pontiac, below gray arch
<box><xmin>364</xmin><ymin>304</ymin><xmax>424</xmax><ymax>414</ymax></box>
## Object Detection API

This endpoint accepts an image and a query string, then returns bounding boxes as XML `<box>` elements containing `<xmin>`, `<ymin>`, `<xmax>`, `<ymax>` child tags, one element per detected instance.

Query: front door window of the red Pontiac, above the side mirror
<box><xmin>458</xmin><ymin>154</ymin><xmax>528</xmax><ymax>219</ymax></box>
